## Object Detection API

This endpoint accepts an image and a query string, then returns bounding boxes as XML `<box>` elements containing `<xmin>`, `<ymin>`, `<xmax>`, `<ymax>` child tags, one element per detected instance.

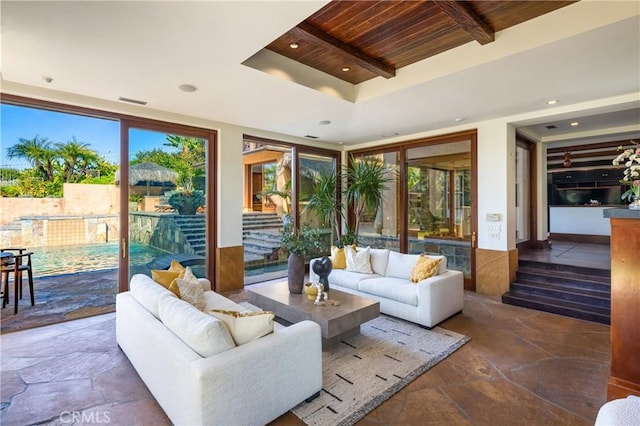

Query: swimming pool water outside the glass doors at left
<box><xmin>29</xmin><ymin>242</ymin><xmax>167</xmax><ymax>277</ymax></box>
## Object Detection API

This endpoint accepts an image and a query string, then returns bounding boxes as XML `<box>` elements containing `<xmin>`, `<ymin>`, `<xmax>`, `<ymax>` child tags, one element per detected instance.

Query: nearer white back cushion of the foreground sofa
<box><xmin>158</xmin><ymin>297</ymin><xmax>235</xmax><ymax>358</ymax></box>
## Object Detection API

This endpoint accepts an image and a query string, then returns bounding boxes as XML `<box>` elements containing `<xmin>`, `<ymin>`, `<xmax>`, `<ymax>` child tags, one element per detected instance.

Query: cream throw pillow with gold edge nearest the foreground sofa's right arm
<box><xmin>209</xmin><ymin>309</ymin><xmax>275</xmax><ymax>346</ymax></box>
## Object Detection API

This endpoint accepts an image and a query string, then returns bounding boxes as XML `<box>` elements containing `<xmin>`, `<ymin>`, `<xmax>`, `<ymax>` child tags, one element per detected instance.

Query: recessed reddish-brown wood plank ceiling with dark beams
<box><xmin>266</xmin><ymin>0</ymin><xmax>575</xmax><ymax>84</ymax></box>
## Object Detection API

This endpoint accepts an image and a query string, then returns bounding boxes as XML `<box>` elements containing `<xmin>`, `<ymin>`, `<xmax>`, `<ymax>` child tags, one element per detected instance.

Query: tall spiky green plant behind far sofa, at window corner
<box><xmin>345</xmin><ymin>157</ymin><xmax>393</xmax><ymax>242</ymax></box>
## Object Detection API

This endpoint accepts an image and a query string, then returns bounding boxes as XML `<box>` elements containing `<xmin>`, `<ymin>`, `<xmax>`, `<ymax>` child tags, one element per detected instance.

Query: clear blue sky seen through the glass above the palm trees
<box><xmin>0</xmin><ymin>104</ymin><xmax>175</xmax><ymax>168</ymax></box>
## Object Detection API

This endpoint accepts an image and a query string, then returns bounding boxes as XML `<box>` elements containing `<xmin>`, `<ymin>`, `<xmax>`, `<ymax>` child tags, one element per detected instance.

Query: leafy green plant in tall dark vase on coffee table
<box><xmin>280</xmin><ymin>217</ymin><xmax>321</xmax><ymax>294</ymax></box>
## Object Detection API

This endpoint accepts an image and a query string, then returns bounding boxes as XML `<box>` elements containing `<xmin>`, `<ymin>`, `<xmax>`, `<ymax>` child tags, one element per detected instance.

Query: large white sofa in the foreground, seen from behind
<box><xmin>116</xmin><ymin>274</ymin><xmax>322</xmax><ymax>425</ymax></box>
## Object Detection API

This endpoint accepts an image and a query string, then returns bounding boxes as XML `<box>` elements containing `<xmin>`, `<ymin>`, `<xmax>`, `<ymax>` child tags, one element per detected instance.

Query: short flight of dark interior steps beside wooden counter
<box><xmin>502</xmin><ymin>260</ymin><xmax>611</xmax><ymax>324</ymax></box>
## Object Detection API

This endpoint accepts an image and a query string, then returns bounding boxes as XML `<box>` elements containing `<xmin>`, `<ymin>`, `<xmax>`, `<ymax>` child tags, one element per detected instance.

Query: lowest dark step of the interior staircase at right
<box><xmin>502</xmin><ymin>291</ymin><xmax>611</xmax><ymax>324</ymax></box>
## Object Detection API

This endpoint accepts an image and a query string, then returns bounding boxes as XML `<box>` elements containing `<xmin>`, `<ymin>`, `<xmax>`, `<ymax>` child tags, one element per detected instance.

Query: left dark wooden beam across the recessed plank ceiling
<box><xmin>290</xmin><ymin>22</ymin><xmax>396</xmax><ymax>78</ymax></box>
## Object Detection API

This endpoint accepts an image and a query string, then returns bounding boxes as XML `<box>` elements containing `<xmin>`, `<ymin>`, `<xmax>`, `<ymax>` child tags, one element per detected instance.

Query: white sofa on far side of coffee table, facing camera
<box><xmin>309</xmin><ymin>249</ymin><xmax>464</xmax><ymax>328</ymax></box>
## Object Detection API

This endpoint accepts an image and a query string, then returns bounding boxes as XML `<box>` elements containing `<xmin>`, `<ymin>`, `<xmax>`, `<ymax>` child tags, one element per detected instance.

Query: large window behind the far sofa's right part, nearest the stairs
<box><xmin>349</xmin><ymin>132</ymin><xmax>476</xmax><ymax>289</ymax></box>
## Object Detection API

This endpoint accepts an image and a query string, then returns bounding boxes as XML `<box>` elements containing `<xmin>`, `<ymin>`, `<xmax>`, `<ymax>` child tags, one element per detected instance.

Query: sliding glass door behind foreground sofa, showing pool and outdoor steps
<box><xmin>121</xmin><ymin>122</ymin><xmax>215</xmax><ymax>290</ymax></box>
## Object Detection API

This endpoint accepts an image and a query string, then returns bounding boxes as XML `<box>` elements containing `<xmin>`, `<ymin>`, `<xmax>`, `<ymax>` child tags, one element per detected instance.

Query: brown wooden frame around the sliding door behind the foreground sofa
<box><xmin>118</xmin><ymin>118</ymin><xmax>218</xmax><ymax>292</ymax></box>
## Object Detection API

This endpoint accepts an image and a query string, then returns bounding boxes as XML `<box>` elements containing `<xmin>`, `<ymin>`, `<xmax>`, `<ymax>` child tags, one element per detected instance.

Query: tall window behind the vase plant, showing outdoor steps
<box><xmin>242</xmin><ymin>135</ymin><xmax>339</xmax><ymax>285</ymax></box>
